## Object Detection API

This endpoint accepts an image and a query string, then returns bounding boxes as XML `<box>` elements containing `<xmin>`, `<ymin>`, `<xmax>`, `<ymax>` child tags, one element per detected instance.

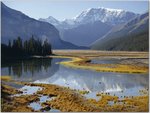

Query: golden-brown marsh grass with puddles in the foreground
<box><xmin>2</xmin><ymin>77</ymin><xmax>149</xmax><ymax>112</ymax></box>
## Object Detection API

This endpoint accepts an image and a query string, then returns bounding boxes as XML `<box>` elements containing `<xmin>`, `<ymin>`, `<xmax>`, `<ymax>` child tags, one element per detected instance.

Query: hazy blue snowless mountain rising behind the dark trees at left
<box><xmin>1</xmin><ymin>2</ymin><xmax>83</xmax><ymax>49</ymax></box>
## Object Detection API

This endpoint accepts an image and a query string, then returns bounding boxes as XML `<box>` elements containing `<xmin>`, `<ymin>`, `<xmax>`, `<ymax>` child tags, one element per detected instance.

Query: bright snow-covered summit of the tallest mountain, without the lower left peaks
<box><xmin>73</xmin><ymin>7</ymin><xmax>137</xmax><ymax>25</ymax></box>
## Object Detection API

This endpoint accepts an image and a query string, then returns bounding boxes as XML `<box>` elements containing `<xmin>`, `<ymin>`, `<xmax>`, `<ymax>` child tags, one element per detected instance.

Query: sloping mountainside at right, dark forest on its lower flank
<box><xmin>91</xmin><ymin>12</ymin><xmax>149</xmax><ymax>51</ymax></box>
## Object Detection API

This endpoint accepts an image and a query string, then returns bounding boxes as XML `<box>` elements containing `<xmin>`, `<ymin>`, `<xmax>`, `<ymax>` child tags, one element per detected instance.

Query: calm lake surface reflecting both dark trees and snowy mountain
<box><xmin>1</xmin><ymin>58</ymin><xmax>149</xmax><ymax>98</ymax></box>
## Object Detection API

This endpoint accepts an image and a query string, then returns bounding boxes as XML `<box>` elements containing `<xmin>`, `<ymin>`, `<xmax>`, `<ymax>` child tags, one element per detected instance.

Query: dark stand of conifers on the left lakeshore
<box><xmin>1</xmin><ymin>36</ymin><xmax>52</xmax><ymax>58</ymax></box>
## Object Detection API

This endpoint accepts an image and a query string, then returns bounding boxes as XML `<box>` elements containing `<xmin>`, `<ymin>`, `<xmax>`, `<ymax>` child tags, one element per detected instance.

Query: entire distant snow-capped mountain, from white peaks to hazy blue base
<box><xmin>39</xmin><ymin>7</ymin><xmax>139</xmax><ymax>47</ymax></box>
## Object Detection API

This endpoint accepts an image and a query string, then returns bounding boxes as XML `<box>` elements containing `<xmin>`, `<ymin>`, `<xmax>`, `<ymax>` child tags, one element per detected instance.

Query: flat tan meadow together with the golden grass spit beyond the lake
<box><xmin>51</xmin><ymin>50</ymin><xmax>148</xmax><ymax>73</ymax></box>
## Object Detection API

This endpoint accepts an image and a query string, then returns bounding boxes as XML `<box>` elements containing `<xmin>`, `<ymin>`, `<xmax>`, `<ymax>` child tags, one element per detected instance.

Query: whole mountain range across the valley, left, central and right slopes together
<box><xmin>1</xmin><ymin>2</ymin><xmax>149</xmax><ymax>51</ymax></box>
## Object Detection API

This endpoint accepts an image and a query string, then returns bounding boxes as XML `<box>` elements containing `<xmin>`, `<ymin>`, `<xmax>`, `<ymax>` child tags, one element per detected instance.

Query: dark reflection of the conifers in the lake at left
<box><xmin>2</xmin><ymin>58</ymin><xmax>52</xmax><ymax>77</ymax></box>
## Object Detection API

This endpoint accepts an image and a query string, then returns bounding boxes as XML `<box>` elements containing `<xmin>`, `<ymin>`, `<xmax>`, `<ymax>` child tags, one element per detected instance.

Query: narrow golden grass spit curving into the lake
<box><xmin>49</xmin><ymin>55</ymin><xmax>149</xmax><ymax>74</ymax></box>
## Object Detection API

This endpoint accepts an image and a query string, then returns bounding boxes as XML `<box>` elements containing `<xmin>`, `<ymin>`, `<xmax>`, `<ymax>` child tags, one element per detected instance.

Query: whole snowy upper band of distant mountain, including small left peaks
<box><xmin>39</xmin><ymin>7</ymin><xmax>138</xmax><ymax>29</ymax></box>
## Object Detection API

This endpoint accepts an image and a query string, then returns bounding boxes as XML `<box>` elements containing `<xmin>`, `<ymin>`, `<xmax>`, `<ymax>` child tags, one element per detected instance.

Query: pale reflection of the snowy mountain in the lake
<box><xmin>35</xmin><ymin>63</ymin><xmax>148</xmax><ymax>92</ymax></box>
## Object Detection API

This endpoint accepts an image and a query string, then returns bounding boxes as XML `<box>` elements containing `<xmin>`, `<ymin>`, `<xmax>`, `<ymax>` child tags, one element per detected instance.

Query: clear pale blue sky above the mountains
<box><xmin>2</xmin><ymin>0</ymin><xmax>148</xmax><ymax>21</ymax></box>
